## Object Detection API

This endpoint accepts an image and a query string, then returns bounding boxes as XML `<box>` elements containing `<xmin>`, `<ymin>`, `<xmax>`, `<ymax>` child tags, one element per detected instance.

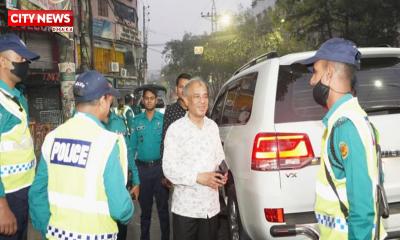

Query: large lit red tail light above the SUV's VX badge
<box><xmin>251</xmin><ymin>133</ymin><xmax>314</xmax><ymax>171</ymax></box>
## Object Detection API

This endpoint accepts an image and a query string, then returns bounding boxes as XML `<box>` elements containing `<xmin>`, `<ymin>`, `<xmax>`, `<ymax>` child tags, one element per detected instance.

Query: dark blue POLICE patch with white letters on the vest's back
<box><xmin>50</xmin><ymin>138</ymin><xmax>91</xmax><ymax>168</ymax></box>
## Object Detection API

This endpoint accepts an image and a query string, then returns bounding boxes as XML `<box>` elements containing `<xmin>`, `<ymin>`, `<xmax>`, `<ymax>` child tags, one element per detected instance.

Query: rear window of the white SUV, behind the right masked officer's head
<box><xmin>275</xmin><ymin>57</ymin><xmax>400</xmax><ymax>123</ymax></box>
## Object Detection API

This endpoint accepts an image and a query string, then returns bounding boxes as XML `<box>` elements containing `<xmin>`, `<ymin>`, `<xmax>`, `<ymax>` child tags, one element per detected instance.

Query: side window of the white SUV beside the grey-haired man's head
<box><xmin>220</xmin><ymin>73</ymin><xmax>257</xmax><ymax>125</ymax></box>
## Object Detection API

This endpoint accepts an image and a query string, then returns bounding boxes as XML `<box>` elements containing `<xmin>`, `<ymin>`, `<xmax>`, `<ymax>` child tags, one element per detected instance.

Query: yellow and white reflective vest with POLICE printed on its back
<box><xmin>42</xmin><ymin>113</ymin><xmax>127</xmax><ymax>235</ymax></box>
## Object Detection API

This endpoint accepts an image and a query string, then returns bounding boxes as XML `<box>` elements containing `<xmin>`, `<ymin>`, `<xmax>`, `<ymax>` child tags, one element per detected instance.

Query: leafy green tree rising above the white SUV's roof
<box><xmin>162</xmin><ymin>0</ymin><xmax>400</xmax><ymax>100</ymax></box>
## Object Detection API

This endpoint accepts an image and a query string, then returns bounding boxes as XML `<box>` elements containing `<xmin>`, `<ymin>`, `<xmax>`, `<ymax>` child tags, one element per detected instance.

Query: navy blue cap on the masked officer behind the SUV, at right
<box><xmin>299</xmin><ymin>38</ymin><xmax>361</xmax><ymax>68</ymax></box>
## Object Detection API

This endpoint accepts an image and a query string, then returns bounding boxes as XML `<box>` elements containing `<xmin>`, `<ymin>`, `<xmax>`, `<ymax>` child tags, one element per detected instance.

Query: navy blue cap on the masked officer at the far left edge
<box><xmin>0</xmin><ymin>33</ymin><xmax>40</xmax><ymax>61</ymax></box>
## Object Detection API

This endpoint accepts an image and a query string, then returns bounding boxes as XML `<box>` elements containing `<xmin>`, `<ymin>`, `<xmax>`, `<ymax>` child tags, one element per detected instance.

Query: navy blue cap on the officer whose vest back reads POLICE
<box><xmin>74</xmin><ymin>70</ymin><xmax>120</xmax><ymax>102</ymax></box>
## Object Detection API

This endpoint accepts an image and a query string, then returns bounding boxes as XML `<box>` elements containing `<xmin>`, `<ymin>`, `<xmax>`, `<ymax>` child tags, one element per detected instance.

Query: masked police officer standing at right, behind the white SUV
<box><xmin>301</xmin><ymin>38</ymin><xmax>384</xmax><ymax>240</ymax></box>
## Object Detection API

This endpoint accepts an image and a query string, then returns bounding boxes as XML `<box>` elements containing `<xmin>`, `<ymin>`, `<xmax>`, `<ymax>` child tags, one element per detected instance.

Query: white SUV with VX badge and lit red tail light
<box><xmin>211</xmin><ymin>48</ymin><xmax>400</xmax><ymax>239</ymax></box>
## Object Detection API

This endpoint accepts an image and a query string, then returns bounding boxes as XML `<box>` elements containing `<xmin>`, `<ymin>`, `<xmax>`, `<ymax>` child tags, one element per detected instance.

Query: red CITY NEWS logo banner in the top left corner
<box><xmin>7</xmin><ymin>10</ymin><xmax>74</xmax><ymax>32</ymax></box>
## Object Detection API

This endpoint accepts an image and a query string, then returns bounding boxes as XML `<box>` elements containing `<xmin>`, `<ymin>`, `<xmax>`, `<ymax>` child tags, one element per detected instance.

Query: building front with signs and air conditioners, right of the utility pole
<box><xmin>91</xmin><ymin>0</ymin><xmax>141</xmax><ymax>95</ymax></box>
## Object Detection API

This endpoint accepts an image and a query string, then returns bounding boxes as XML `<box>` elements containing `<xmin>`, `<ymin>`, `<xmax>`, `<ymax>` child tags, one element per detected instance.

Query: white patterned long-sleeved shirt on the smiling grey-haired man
<box><xmin>163</xmin><ymin>114</ymin><xmax>225</xmax><ymax>218</ymax></box>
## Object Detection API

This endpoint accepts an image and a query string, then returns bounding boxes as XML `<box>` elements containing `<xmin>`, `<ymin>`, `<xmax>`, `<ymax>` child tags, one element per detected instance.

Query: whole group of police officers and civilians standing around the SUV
<box><xmin>0</xmin><ymin>34</ymin><xmax>384</xmax><ymax>240</ymax></box>
